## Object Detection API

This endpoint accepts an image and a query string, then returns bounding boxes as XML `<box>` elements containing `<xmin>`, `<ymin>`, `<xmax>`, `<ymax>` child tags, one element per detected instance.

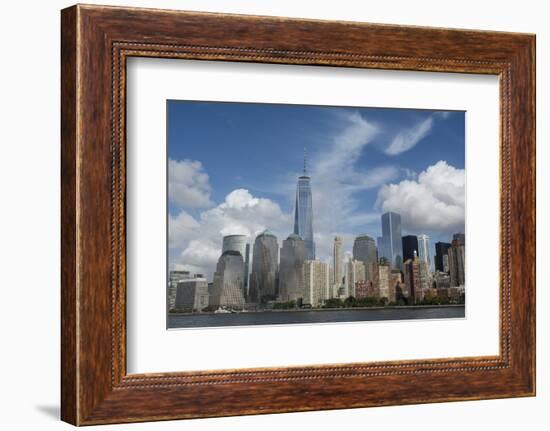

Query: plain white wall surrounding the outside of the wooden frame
<box><xmin>0</xmin><ymin>0</ymin><xmax>550</xmax><ymax>431</ymax></box>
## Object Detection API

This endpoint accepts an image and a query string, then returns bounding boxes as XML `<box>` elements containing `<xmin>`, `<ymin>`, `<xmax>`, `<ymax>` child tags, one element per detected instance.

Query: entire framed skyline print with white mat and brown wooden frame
<box><xmin>61</xmin><ymin>5</ymin><xmax>535</xmax><ymax>425</ymax></box>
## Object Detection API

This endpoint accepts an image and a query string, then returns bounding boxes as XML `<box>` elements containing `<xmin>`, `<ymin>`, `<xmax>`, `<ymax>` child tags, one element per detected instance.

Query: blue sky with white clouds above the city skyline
<box><xmin>167</xmin><ymin>101</ymin><xmax>465</xmax><ymax>278</ymax></box>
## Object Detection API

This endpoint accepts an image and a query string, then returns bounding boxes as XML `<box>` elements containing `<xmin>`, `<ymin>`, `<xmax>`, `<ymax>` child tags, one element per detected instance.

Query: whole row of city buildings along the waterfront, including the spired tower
<box><xmin>167</xmin><ymin>157</ymin><xmax>465</xmax><ymax>312</ymax></box>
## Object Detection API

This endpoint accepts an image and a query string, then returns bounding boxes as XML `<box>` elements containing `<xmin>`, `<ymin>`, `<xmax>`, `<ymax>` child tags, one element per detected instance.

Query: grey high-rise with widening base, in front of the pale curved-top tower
<box><xmin>211</xmin><ymin>250</ymin><xmax>245</xmax><ymax>308</ymax></box>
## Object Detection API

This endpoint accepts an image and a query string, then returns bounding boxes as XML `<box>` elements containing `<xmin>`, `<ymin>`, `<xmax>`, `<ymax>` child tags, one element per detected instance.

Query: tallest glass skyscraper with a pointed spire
<box><xmin>294</xmin><ymin>150</ymin><xmax>315</xmax><ymax>260</ymax></box>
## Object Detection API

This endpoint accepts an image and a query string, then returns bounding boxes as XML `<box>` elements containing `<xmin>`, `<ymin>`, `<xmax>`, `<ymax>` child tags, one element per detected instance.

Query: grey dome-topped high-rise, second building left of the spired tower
<box><xmin>248</xmin><ymin>230</ymin><xmax>279</xmax><ymax>303</ymax></box>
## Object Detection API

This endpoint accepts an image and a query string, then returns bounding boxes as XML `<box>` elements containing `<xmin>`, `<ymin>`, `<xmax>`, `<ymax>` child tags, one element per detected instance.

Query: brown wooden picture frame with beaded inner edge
<box><xmin>61</xmin><ymin>5</ymin><xmax>535</xmax><ymax>425</ymax></box>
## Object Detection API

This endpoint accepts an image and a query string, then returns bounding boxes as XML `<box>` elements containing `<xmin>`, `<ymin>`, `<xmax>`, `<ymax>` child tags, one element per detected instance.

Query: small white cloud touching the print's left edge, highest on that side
<box><xmin>168</xmin><ymin>159</ymin><xmax>213</xmax><ymax>208</ymax></box>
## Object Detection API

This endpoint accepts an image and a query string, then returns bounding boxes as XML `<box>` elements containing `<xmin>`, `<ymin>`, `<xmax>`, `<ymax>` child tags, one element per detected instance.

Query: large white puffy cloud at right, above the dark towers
<box><xmin>377</xmin><ymin>160</ymin><xmax>465</xmax><ymax>233</ymax></box>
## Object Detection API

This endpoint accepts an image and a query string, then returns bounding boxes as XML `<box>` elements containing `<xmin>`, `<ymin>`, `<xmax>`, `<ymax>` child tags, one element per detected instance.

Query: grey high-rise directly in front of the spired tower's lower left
<box><xmin>279</xmin><ymin>233</ymin><xmax>307</xmax><ymax>301</ymax></box>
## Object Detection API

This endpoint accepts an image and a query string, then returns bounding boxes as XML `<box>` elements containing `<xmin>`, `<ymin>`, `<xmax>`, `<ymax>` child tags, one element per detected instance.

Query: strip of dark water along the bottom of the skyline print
<box><xmin>168</xmin><ymin>305</ymin><xmax>465</xmax><ymax>328</ymax></box>
